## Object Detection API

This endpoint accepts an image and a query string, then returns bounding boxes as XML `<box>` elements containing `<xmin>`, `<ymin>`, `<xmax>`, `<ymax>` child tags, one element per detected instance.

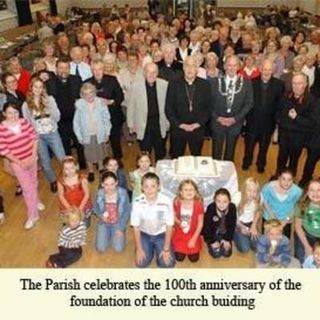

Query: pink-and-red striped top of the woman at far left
<box><xmin>0</xmin><ymin>119</ymin><xmax>37</xmax><ymax>160</ymax></box>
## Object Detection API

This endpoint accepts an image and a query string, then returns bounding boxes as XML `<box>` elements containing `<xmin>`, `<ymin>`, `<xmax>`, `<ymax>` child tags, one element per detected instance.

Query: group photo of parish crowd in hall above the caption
<box><xmin>0</xmin><ymin>0</ymin><xmax>320</xmax><ymax>269</ymax></box>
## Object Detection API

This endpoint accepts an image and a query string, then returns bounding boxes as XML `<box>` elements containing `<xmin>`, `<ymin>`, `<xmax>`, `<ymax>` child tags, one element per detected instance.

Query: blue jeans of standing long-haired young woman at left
<box><xmin>38</xmin><ymin>130</ymin><xmax>66</xmax><ymax>183</ymax></box>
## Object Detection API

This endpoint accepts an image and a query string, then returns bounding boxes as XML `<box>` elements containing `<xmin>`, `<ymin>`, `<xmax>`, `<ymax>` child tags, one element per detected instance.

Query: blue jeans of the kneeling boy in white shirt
<box><xmin>137</xmin><ymin>232</ymin><xmax>176</xmax><ymax>268</ymax></box>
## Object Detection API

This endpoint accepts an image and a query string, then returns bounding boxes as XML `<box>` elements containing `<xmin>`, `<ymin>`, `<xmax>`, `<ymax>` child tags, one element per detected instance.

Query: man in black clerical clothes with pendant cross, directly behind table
<box><xmin>166</xmin><ymin>56</ymin><xmax>211</xmax><ymax>158</ymax></box>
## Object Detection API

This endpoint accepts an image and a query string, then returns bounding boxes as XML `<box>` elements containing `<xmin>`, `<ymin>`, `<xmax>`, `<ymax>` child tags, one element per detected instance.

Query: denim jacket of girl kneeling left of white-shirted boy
<box><xmin>93</xmin><ymin>187</ymin><xmax>131</xmax><ymax>231</ymax></box>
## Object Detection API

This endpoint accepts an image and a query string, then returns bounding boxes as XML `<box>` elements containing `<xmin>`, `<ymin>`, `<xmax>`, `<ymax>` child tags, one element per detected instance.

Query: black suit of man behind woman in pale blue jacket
<box><xmin>87</xmin><ymin>75</ymin><xmax>125</xmax><ymax>159</ymax></box>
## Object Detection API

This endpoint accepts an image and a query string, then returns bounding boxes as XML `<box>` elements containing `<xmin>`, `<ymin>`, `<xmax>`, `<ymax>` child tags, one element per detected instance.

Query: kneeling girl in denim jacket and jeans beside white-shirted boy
<box><xmin>94</xmin><ymin>171</ymin><xmax>131</xmax><ymax>252</ymax></box>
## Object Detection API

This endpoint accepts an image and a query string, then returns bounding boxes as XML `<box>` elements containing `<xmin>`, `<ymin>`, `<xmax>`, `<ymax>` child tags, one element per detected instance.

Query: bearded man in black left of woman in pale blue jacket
<box><xmin>46</xmin><ymin>58</ymin><xmax>86</xmax><ymax>169</ymax></box>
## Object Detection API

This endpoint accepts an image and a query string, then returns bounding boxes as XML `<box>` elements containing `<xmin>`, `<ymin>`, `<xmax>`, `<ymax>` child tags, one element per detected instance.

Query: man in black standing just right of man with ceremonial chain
<box><xmin>242</xmin><ymin>60</ymin><xmax>284</xmax><ymax>173</ymax></box>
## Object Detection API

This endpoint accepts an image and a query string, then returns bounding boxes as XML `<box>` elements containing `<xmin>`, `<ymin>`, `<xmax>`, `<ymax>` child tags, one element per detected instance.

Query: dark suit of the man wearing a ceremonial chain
<box><xmin>211</xmin><ymin>76</ymin><xmax>253</xmax><ymax>161</ymax></box>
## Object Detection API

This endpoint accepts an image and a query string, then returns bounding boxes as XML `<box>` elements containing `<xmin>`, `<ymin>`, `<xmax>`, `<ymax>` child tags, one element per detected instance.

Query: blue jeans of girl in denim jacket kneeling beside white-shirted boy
<box><xmin>96</xmin><ymin>221</ymin><xmax>126</xmax><ymax>252</ymax></box>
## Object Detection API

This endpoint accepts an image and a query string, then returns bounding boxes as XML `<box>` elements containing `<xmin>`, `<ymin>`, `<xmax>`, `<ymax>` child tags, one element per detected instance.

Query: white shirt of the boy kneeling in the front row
<box><xmin>131</xmin><ymin>193</ymin><xmax>174</xmax><ymax>236</ymax></box>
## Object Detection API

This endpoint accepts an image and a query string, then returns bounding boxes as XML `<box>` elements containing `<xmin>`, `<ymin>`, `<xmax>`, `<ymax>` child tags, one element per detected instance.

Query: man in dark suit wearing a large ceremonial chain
<box><xmin>211</xmin><ymin>56</ymin><xmax>253</xmax><ymax>161</ymax></box>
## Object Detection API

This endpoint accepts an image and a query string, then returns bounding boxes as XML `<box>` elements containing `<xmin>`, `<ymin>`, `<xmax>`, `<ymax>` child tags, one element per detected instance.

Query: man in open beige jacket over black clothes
<box><xmin>127</xmin><ymin>62</ymin><xmax>169</xmax><ymax>160</ymax></box>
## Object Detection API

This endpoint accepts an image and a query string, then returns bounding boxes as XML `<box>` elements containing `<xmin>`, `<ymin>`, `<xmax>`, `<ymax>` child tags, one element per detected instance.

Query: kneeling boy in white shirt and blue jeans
<box><xmin>131</xmin><ymin>172</ymin><xmax>175</xmax><ymax>268</ymax></box>
